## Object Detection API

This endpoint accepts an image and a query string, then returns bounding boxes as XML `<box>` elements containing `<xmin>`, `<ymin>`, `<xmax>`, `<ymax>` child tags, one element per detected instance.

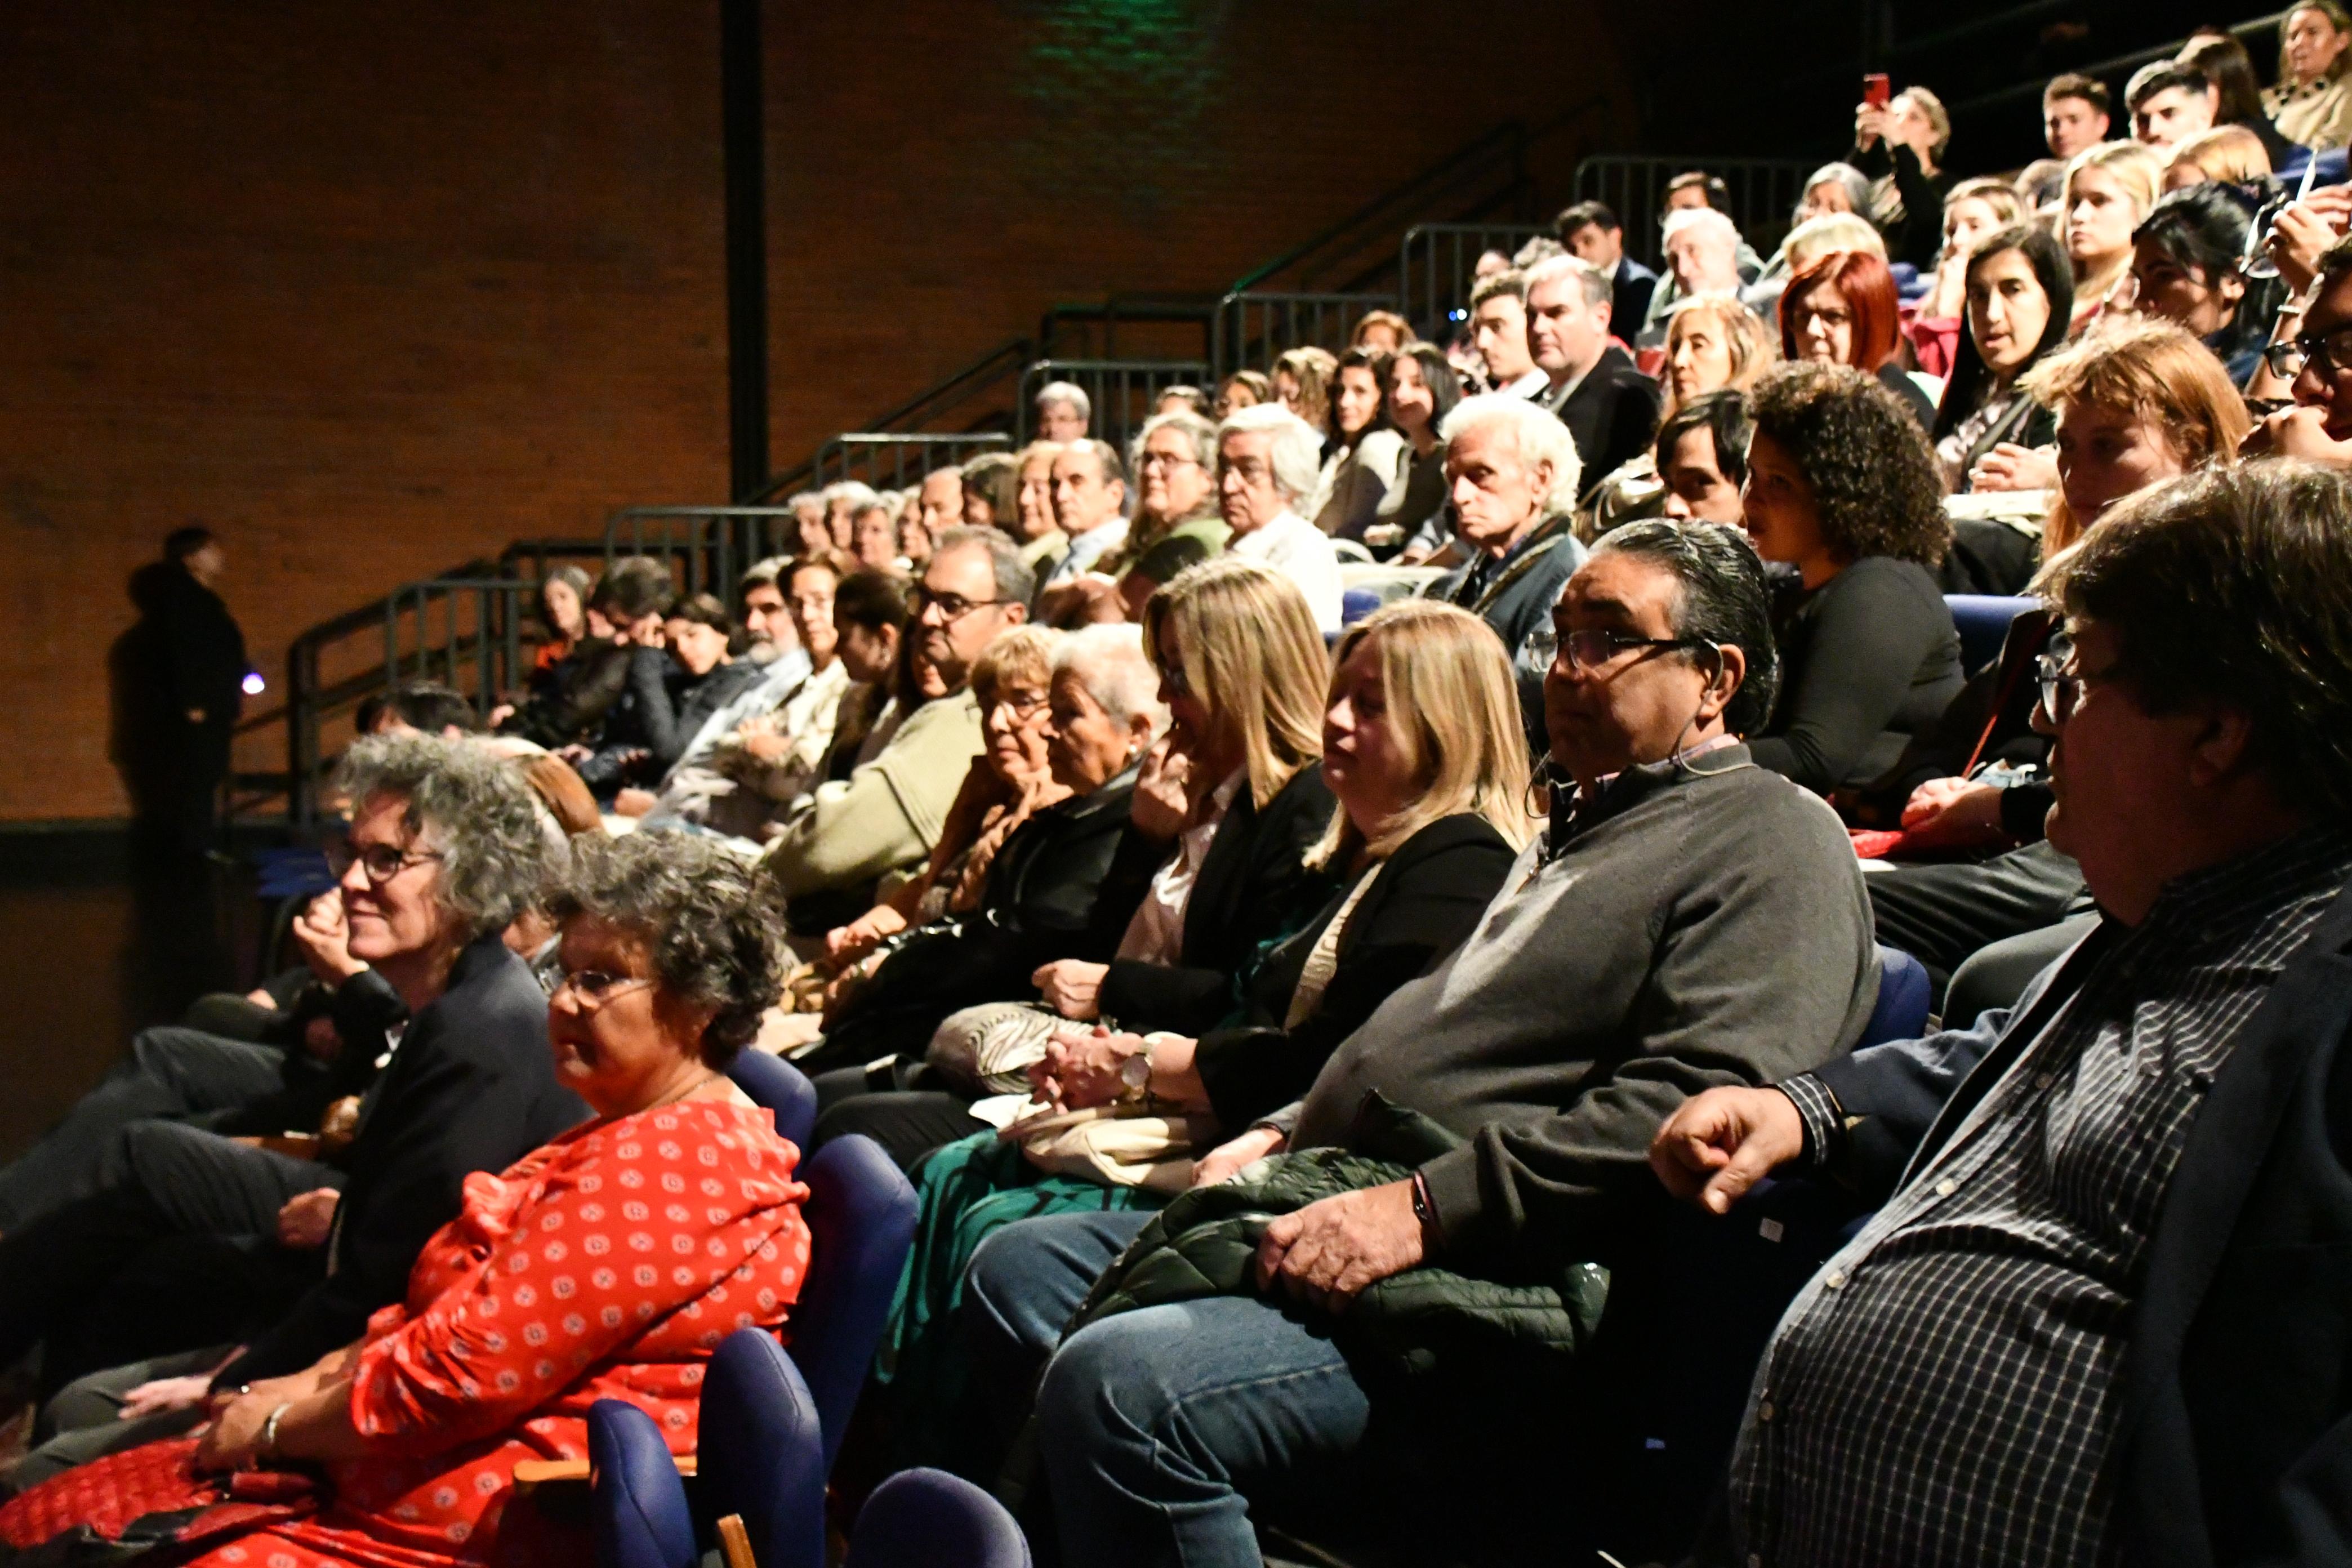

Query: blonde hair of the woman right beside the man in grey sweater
<box><xmin>1308</xmin><ymin>599</ymin><xmax>1534</xmax><ymax>870</ymax></box>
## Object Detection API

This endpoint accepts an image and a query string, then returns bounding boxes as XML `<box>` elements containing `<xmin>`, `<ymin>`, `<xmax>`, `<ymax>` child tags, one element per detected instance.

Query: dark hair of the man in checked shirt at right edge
<box><xmin>2034</xmin><ymin>461</ymin><xmax>2352</xmax><ymax>821</ymax></box>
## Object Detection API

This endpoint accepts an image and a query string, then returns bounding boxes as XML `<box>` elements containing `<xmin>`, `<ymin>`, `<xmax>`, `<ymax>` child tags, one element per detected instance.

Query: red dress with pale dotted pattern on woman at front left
<box><xmin>0</xmin><ymin>1100</ymin><xmax>809</xmax><ymax>1568</ymax></box>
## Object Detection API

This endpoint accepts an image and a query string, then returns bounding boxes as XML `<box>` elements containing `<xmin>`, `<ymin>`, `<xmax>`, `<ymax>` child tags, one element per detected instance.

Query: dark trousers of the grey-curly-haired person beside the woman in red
<box><xmin>0</xmin><ymin>1121</ymin><xmax>344</xmax><ymax>1394</ymax></box>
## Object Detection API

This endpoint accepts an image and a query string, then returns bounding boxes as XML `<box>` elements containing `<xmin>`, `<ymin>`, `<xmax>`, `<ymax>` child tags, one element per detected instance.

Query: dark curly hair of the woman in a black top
<box><xmin>1750</xmin><ymin>362</ymin><xmax>1952</xmax><ymax>571</ymax></box>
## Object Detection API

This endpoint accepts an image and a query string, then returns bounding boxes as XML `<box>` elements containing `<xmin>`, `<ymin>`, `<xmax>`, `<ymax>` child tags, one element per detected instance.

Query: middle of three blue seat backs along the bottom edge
<box><xmin>696</xmin><ymin>1328</ymin><xmax>828</xmax><ymax>1568</ymax></box>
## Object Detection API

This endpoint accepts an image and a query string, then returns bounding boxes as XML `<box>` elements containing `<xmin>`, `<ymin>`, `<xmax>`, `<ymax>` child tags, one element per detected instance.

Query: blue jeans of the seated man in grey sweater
<box><xmin>964</xmin><ymin>1213</ymin><xmax>1371</xmax><ymax>1568</ymax></box>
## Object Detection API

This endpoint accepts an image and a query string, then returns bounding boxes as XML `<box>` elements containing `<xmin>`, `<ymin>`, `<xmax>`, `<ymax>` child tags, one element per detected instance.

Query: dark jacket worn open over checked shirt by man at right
<box><xmin>1818</xmin><ymin>893</ymin><xmax>2352</xmax><ymax>1568</ymax></box>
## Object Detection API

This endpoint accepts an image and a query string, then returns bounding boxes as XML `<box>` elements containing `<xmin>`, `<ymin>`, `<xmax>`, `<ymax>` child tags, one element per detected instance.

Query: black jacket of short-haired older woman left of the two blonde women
<box><xmin>800</xmin><ymin>769</ymin><xmax>1143</xmax><ymax>1072</ymax></box>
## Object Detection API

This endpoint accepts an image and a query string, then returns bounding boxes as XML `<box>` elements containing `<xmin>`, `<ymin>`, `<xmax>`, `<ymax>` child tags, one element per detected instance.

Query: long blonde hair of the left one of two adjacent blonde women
<box><xmin>1143</xmin><ymin>555</ymin><xmax>1331</xmax><ymax>809</ymax></box>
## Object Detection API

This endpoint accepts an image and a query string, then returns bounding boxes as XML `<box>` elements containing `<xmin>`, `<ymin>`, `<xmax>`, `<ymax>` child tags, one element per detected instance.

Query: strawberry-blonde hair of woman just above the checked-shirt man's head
<box><xmin>2018</xmin><ymin>317</ymin><xmax>2253</xmax><ymax>559</ymax></box>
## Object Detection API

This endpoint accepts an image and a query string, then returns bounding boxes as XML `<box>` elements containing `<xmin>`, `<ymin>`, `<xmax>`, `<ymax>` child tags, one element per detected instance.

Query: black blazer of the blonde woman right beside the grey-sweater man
<box><xmin>1192</xmin><ymin>813</ymin><xmax>1517</xmax><ymax>1133</ymax></box>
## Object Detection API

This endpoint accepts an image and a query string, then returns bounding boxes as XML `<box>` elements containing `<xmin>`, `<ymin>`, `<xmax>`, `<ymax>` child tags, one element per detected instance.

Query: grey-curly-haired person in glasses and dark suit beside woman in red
<box><xmin>0</xmin><ymin>736</ymin><xmax>586</xmax><ymax>1476</ymax></box>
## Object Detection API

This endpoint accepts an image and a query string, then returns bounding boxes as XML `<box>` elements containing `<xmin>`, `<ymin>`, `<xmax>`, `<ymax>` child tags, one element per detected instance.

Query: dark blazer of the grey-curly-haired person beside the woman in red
<box><xmin>214</xmin><ymin>933</ymin><xmax>588</xmax><ymax>1389</ymax></box>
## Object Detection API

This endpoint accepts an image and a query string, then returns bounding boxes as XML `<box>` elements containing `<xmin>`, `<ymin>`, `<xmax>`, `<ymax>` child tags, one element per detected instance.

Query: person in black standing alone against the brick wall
<box><xmin>115</xmin><ymin>527</ymin><xmax>250</xmax><ymax>867</ymax></box>
